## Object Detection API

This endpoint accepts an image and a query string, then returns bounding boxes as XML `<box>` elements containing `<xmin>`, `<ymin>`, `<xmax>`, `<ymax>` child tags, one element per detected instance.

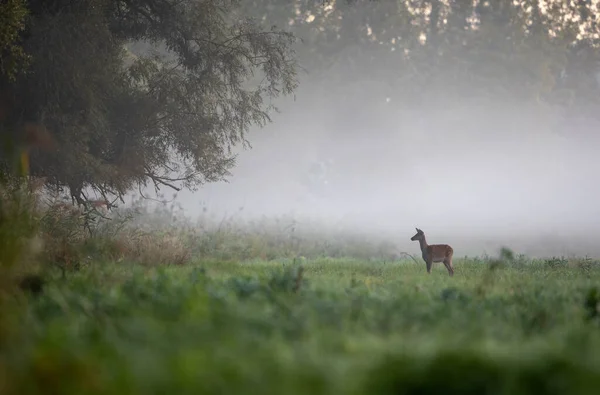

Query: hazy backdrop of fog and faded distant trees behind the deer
<box><xmin>115</xmin><ymin>0</ymin><xmax>600</xmax><ymax>255</ymax></box>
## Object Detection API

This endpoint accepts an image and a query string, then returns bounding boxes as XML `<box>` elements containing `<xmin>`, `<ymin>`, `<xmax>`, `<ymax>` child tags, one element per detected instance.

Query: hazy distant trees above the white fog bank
<box><xmin>246</xmin><ymin>0</ymin><xmax>600</xmax><ymax>113</ymax></box>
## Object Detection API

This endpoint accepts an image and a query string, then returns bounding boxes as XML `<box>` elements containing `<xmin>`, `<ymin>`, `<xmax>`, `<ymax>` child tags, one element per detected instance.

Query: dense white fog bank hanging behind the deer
<box><xmin>130</xmin><ymin>75</ymin><xmax>600</xmax><ymax>256</ymax></box>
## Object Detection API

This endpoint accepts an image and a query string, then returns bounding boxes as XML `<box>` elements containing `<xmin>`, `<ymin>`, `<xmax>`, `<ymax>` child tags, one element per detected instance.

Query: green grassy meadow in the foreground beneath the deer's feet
<box><xmin>0</xmin><ymin>259</ymin><xmax>600</xmax><ymax>394</ymax></box>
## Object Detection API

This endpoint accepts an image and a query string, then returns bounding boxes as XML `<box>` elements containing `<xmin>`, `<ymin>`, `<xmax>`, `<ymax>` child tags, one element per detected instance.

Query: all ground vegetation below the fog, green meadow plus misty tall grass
<box><xmin>0</xmin><ymin>189</ymin><xmax>600</xmax><ymax>394</ymax></box>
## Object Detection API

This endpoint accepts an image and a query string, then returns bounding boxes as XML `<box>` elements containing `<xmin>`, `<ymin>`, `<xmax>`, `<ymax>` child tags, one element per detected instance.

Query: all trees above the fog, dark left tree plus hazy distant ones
<box><xmin>0</xmin><ymin>0</ymin><xmax>600</xmax><ymax>202</ymax></box>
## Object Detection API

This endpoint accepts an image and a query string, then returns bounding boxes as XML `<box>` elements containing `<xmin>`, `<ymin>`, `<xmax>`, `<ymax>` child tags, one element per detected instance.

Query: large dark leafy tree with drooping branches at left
<box><xmin>0</xmin><ymin>0</ymin><xmax>297</xmax><ymax>203</ymax></box>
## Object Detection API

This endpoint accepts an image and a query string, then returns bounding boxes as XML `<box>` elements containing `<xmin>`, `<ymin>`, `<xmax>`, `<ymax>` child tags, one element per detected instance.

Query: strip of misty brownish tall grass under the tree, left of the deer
<box><xmin>18</xmin><ymin>194</ymin><xmax>410</xmax><ymax>269</ymax></box>
